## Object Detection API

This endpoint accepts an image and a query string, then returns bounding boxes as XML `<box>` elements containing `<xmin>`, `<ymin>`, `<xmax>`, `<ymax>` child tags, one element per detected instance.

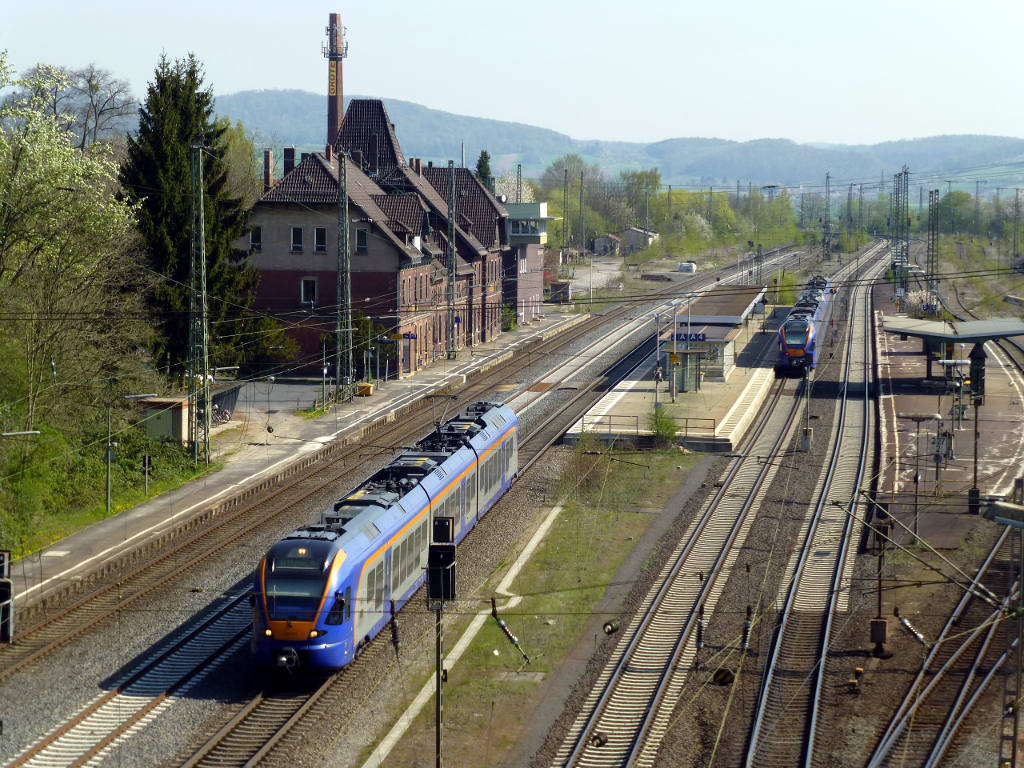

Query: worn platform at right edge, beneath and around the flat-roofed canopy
<box><xmin>874</xmin><ymin>284</ymin><xmax>1024</xmax><ymax>550</ymax></box>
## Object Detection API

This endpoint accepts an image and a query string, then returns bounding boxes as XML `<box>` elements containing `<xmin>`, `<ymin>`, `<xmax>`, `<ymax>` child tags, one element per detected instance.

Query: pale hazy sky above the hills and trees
<box><xmin>0</xmin><ymin>0</ymin><xmax>1024</xmax><ymax>143</ymax></box>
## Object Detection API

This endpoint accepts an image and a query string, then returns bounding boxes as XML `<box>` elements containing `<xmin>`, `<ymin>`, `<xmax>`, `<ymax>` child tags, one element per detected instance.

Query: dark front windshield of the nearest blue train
<box><xmin>264</xmin><ymin>539</ymin><xmax>331</xmax><ymax>622</ymax></box>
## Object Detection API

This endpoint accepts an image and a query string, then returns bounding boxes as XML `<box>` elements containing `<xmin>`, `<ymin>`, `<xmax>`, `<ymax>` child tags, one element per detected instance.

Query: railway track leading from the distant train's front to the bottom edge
<box><xmin>554</xmin><ymin>380</ymin><xmax>799</xmax><ymax>766</ymax></box>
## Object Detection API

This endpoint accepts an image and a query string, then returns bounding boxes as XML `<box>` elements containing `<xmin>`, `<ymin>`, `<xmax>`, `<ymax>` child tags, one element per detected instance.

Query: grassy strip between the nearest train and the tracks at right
<box><xmin>374</xmin><ymin>441</ymin><xmax>701</xmax><ymax>767</ymax></box>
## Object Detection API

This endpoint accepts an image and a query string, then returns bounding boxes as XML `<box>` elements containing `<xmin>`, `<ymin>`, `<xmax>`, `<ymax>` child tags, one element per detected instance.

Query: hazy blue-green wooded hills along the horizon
<box><xmin>217</xmin><ymin>90</ymin><xmax>1024</xmax><ymax>186</ymax></box>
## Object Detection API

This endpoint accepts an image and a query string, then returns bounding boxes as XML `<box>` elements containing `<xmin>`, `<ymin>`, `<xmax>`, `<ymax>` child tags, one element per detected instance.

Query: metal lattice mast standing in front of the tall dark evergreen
<box><xmin>188</xmin><ymin>143</ymin><xmax>210</xmax><ymax>467</ymax></box>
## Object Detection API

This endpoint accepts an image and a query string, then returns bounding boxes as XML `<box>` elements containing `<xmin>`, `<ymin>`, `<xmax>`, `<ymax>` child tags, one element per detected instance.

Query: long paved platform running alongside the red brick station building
<box><xmin>11</xmin><ymin>310</ymin><xmax>589</xmax><ymax>609</ymax></box>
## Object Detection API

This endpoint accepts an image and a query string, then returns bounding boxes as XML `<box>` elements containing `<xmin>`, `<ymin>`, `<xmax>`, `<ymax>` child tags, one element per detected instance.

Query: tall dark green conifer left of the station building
<box><xmin>121</xmin><ymin>54</ymin><xmax>257</xmax><ymax>381</ymax></box>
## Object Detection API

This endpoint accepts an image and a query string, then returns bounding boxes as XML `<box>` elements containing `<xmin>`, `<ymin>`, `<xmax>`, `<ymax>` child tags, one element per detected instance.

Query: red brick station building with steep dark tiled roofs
<box><xmin>239</xmin><ymin>25</ymin><xmax>543</xmax><ymax>376</ymax></box>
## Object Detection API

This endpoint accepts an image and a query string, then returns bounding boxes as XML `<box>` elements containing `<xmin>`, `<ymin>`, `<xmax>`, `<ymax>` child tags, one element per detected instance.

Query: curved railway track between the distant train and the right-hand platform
<box><xmin>743</xmin><ymin>256</ymin><xmax>878</xmax><ymax>768</ymax></box>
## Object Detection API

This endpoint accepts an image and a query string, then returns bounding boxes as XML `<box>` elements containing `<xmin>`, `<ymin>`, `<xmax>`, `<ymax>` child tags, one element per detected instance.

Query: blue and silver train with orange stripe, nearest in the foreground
<box><xmin>251</xmin><ymin>402</ymin><xmax>519</xmax><ymax>670</ymax></box>
